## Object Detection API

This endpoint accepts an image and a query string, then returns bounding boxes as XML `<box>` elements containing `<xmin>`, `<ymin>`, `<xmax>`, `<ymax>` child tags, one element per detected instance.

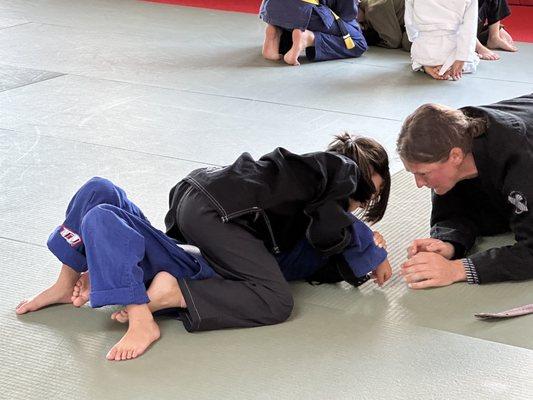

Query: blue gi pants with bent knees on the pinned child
<box><xmin>48</xmin><ymin>178</ymin><xmax>215</xmax><ymax>307</ymax></box>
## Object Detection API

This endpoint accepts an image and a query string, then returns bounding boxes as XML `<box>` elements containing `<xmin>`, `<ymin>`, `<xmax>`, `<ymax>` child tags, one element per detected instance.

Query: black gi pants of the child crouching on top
<box><xmin>172</xmin><ymin>184</ymin><xmax>294</xmax><ymax>332</ymax></box>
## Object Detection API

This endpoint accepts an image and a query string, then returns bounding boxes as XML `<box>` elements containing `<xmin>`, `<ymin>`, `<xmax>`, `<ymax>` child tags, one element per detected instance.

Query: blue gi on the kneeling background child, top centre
<box><xmin>259</xmin><ymin>0</ymin><xmax>368</xmax><ymax>61</ymax></box>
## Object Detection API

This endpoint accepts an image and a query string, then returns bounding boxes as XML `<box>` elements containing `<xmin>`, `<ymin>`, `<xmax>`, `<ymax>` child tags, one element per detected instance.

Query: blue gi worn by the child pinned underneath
<box><xmin>47</xmin><ymin>178</ymin><xmax>387</xmax><ymax>307</ymax></box>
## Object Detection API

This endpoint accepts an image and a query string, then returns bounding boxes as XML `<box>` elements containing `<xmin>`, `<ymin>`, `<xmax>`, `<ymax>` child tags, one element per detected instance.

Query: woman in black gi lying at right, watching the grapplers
<box><xmin>398</xmin><ymin>94</ymin><xmax>533</xmax><ymax>289</ymax></box>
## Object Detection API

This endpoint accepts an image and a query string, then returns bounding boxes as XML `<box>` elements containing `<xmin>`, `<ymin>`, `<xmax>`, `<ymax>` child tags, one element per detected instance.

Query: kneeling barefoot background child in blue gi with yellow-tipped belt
<box><xmin>259</xmin><ymin>0</ymin><xmax>367</xmax><ymax>65</ymax></box>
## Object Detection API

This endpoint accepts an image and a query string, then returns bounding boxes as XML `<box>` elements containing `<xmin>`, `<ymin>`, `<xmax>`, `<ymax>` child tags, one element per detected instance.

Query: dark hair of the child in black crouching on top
<box><xmin>327</xmin><ymin>132</ymin><xmax>391</xmax><ymax>223</ymax></box>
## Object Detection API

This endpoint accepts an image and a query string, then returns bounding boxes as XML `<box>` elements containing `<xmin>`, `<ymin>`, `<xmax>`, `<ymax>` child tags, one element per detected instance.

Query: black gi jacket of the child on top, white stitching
<box><xmin>165</xmin><ymin>148</ymin><xmax>359</xmax><ymax>256</ymax></box>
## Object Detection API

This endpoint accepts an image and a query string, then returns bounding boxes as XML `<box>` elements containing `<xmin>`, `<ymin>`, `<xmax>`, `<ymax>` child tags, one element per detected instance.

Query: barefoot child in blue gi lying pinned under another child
<box><xmin>17</xmin><ymin>134</ymin><xmax>390</xmax><ymax>360</ymax></box>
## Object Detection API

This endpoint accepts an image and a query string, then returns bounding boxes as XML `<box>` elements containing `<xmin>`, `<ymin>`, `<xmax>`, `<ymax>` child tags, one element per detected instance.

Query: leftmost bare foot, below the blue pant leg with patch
<box><xmin>15</xmin><ymin>265</ymin><xmax>79</xmax><ymax>315</ymax></box>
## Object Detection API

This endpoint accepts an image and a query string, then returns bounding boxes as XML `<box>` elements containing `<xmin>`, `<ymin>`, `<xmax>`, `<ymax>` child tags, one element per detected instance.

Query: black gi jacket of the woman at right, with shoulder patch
<box><xmin>431</xmin><ymin>94</ymin><xmax>533</xmax><ymax>283</ymax></box>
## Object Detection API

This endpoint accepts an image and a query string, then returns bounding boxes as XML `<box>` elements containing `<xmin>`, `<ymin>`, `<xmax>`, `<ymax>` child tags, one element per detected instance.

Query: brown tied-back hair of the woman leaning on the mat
<box><xmin>396</xmin><ymin>103</ymin><xmax>487</xmax><ymax>163</ymax></box>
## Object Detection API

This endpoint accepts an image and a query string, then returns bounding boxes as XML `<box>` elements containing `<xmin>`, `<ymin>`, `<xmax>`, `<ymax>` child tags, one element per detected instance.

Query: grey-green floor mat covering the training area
<box><xmin>0</xmin><ymin>0</ymin><xmax>533</xmax><ymax>400</ymax></box>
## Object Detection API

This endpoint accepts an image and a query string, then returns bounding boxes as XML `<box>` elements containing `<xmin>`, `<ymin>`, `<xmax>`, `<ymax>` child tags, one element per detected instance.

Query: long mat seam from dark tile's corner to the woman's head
<box><xmin>63</xmin><ymin>73</ymin><xmax>402</xmax><ymax>122</ymax></box>
